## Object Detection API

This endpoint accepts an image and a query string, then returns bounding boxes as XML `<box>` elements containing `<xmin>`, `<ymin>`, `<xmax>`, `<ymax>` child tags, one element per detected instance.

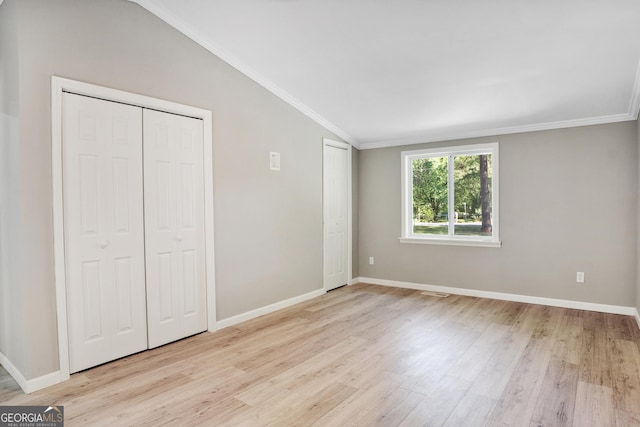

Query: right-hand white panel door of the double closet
<box><xmin>144</xmin><ymin>110</ymin><xmax>207</xmax><ymax>348</ymax></box>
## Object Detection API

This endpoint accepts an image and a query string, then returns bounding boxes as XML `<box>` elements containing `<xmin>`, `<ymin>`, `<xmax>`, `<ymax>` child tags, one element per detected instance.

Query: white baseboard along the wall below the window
<box><xmin>357</xmin><ymin>277</ymin><xmax>640</xmax><ymax>318</ymax></box>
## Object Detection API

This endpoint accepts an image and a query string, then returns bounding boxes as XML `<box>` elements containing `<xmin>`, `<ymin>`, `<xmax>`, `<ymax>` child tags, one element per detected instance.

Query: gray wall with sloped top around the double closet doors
<box><xmin>5</xmin><ymin>0</ymin><xmax>348</xmax><ymax>379</ymax></box>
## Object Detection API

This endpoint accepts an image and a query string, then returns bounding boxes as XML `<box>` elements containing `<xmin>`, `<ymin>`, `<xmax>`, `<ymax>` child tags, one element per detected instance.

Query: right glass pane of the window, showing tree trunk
<box><xmin>453</xmin><ymin>154</ymin><xmax>492</xmax><ymax>236</ymax></box>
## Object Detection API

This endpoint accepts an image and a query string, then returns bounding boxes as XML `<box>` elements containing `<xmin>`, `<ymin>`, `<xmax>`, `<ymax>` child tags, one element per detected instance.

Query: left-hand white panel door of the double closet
<box><xmin>62</xmin><ymin>93</ymin><xmax>147</xmax><ymax>373</ymax></box>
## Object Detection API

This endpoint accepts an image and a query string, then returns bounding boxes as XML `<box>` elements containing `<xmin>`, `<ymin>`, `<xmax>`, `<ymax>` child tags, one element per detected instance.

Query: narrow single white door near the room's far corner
<box><xmin>323</xmin><ymin>144</ymin><xmax>349</xmax><ymax>291</ymax></box>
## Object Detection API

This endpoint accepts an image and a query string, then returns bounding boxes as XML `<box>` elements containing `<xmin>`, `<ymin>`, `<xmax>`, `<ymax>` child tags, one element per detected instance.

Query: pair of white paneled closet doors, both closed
<box><xmin>62</xmin><ymin>93</ymin><xmax>207</xmax><ymax>373</ymax></box>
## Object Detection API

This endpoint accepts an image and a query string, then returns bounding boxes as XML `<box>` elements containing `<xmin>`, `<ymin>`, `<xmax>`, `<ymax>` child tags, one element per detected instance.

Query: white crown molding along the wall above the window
<box><xmin>358</xmin><ymin>111</ymin><xmax>638</xmax><ymax>150</ymax></box>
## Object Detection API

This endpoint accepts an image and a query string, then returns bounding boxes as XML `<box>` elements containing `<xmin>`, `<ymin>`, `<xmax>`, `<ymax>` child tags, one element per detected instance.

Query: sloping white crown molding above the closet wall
<box><xmin>129</xmin><ymin>0</ymin><xmax>358</xmax><ymax>148</ymax></box>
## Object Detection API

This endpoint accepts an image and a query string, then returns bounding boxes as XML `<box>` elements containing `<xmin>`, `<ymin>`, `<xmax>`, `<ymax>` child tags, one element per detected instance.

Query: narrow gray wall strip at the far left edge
<box><xmin>0</xmin><ymin>0</ymin><xmax>27</xmax><ymax>371</ymax></box>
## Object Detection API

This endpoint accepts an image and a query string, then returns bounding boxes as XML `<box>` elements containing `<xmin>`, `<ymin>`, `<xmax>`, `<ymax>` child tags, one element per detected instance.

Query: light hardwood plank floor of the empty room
<box><xmin>0</xmin><ymin>284</ymin><xmax>640</xmax><ymax>427</ymax></box>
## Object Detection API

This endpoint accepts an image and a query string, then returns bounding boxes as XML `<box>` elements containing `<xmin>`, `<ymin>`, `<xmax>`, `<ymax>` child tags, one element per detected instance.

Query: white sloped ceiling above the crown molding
<box><xmin>134</xmin><ymin>0</ymin><xmax>640</xmax><ymax>148</ymax></box>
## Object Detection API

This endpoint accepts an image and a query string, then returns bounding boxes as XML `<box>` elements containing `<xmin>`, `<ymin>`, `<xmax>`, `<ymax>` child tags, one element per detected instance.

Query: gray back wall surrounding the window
<box><xmin>359</xmin><ymin>122</ymin><xmax>638</xmax><ymax>306</ymax></box>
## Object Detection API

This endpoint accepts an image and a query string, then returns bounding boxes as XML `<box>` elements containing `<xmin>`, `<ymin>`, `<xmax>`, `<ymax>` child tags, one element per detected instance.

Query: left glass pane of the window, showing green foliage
<box><xmin>412</xmin><ymin>157</ymin><xmax>449</xmax><ymax>235</ymax></box>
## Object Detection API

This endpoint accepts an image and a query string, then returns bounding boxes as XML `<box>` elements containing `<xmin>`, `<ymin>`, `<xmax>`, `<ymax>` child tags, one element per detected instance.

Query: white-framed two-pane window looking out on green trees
<box><xmin>400</xmin><ymin>143</ymin><xmax>500</xmax><ymax>247</ymax></box>
